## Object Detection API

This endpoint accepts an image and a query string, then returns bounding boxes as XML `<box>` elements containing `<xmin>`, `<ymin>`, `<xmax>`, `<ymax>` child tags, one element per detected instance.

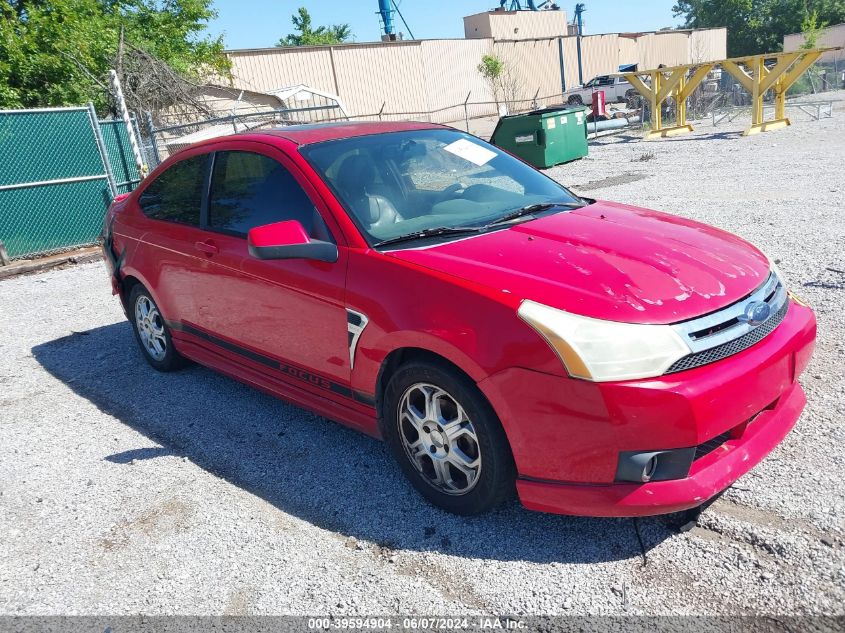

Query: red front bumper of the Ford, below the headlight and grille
<box><xmin>479</xmin><ymin>303</ymin><xmax>816</xmax><ymax>516</ymax></box>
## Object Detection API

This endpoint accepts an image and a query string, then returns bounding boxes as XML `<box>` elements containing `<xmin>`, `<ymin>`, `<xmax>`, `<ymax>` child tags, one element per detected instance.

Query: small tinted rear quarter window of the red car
<box><xmin>138</xmin><ymin>154</ymin><xmax>208</xmax><ymax>226</ymax></box>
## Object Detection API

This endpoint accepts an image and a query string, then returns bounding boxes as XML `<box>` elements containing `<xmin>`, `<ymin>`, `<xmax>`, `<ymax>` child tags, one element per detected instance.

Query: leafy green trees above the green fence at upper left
<box><xmin>0</xmin><ymin>0</ymin><xmax>229</xmax><ymax>111</ymax></box>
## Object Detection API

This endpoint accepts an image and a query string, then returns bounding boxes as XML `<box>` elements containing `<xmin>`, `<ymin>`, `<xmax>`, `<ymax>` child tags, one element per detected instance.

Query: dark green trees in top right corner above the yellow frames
<box><xmin>672</xmin><ymin>0</ymin><xmax>845</xmax><ymax>57</ymax></box>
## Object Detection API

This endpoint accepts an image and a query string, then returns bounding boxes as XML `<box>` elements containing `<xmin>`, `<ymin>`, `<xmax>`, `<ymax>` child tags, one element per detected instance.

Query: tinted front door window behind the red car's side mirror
<box><xmin>208</xmin><ymin>151</ymin><xmax>330</xmax><ymax>240</ymax></box>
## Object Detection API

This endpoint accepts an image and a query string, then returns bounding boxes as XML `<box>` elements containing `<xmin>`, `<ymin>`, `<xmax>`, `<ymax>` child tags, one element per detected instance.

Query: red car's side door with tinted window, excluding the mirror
<box><xmin>185</xmin><ymin>142</ymin><xmax>350</xmax><ymax>400</ymax></box>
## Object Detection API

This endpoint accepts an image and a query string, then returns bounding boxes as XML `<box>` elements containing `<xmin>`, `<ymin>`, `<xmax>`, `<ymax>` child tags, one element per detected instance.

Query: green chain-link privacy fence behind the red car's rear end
<box><xmin>0</xmin><ymin>106</ymin><xmax>140</xmax><ymax>259</ymax></box>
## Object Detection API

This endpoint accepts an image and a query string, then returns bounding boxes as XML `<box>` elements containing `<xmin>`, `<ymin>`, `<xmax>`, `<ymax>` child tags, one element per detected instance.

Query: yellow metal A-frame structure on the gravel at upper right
<box><xmin>614</xmin><ymin>47</ymin><xmax>841</xmax><ymax>139</ymax></box>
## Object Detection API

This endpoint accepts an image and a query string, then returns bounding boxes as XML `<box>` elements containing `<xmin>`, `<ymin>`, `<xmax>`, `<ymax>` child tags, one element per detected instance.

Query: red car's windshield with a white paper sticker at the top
<box><xmin>301</xmin><ymin>129</ymin><xmax>579</xmax><ymax>244</ymax></box>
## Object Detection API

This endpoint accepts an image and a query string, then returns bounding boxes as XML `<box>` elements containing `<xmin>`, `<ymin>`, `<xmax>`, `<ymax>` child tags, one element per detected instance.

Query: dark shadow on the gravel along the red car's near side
<box><xmin>32</xmin><ymin>322</ymin><xmax>674</xmax><ymax>563</ymax></box>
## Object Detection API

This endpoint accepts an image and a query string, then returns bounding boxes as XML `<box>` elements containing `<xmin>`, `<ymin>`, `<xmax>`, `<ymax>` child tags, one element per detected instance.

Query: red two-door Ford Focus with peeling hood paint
<box><xmin>104</xmin><ymin>123</ymin><xmax>816</xmax><ymax>516</ymax></box>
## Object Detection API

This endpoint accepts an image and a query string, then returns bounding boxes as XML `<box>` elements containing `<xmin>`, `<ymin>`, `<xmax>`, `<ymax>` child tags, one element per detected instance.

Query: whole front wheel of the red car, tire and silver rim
<box><xmin>384</xmin><ymin>362</ymin><xmax>515</xmax><ymax>515</ymax></box>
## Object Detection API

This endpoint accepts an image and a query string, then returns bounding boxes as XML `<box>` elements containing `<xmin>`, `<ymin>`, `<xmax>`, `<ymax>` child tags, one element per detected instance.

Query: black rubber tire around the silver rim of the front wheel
<box><xmin>383</xmin><ymin>361</ymin><xmax>516</xmax><ymax>516</ymax></box>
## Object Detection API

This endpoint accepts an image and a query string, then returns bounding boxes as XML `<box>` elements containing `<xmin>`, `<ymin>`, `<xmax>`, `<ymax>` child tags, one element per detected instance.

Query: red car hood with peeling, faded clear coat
<box><xmin>386</xmin><ymin>201</ymin><xmax>769</xmax><ymax>323</ymax></box>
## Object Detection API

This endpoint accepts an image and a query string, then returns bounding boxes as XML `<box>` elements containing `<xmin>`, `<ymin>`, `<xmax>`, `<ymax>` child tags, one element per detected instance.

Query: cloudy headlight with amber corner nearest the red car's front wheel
<box><xmin>518</xmin><ymin>300</ymin><xmax>690</xmax><ymax>382</ymax></box>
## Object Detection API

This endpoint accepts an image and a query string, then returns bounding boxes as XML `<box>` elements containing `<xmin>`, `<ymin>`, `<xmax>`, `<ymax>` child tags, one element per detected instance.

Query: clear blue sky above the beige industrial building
<box><xmin>209</xmin><ymin>0</ymin><xmax>680</xmax><ymax>49</ymax></box>
